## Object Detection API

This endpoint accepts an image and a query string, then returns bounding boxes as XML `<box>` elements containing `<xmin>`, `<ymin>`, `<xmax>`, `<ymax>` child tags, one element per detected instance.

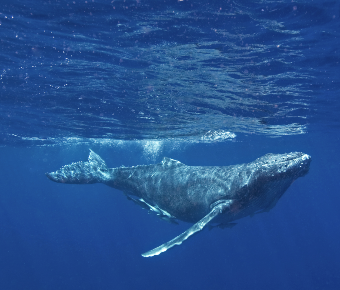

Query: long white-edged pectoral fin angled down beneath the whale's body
<box><xmin>142</xmin><ymin>200</ymin><xmax>232</xmax><ymax>257</ymax></box>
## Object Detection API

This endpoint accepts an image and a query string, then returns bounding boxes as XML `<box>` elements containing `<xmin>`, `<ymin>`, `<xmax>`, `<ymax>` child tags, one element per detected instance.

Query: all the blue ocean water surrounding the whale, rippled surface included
<box><xmin>0</xmin><ymin>0</ymin><xmax>340</xmax><ymax>289</ymax></box>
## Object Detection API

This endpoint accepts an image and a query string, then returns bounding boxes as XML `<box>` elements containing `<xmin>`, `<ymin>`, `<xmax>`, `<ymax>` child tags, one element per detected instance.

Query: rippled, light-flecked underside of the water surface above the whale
<box><xmin>0</xmin><ymin>0</ymin><xmax>339</xmax><ymax>144</ymax></box>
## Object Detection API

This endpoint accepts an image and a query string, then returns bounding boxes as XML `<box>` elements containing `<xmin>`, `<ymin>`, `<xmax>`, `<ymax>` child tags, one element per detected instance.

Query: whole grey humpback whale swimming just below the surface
<box><xmin>46</xmin><ymin>150</ymin><xmax>311</xmax><ymax>257</ymax></box>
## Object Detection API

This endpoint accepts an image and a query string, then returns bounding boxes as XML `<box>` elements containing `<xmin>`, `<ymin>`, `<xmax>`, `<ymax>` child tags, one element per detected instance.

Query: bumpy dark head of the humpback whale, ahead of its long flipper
<box><xmin>219</xmin><ymin>152</ymin><xmax>312</xmax><ymax>221</ymax></box>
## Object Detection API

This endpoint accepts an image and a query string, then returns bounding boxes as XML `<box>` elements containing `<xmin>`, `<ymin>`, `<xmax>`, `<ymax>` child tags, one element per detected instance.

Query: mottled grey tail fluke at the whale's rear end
<box><xmin>46</xmin><ymin>149</ymin><xmax>110</xmax><ymax>184</ymax></box>
